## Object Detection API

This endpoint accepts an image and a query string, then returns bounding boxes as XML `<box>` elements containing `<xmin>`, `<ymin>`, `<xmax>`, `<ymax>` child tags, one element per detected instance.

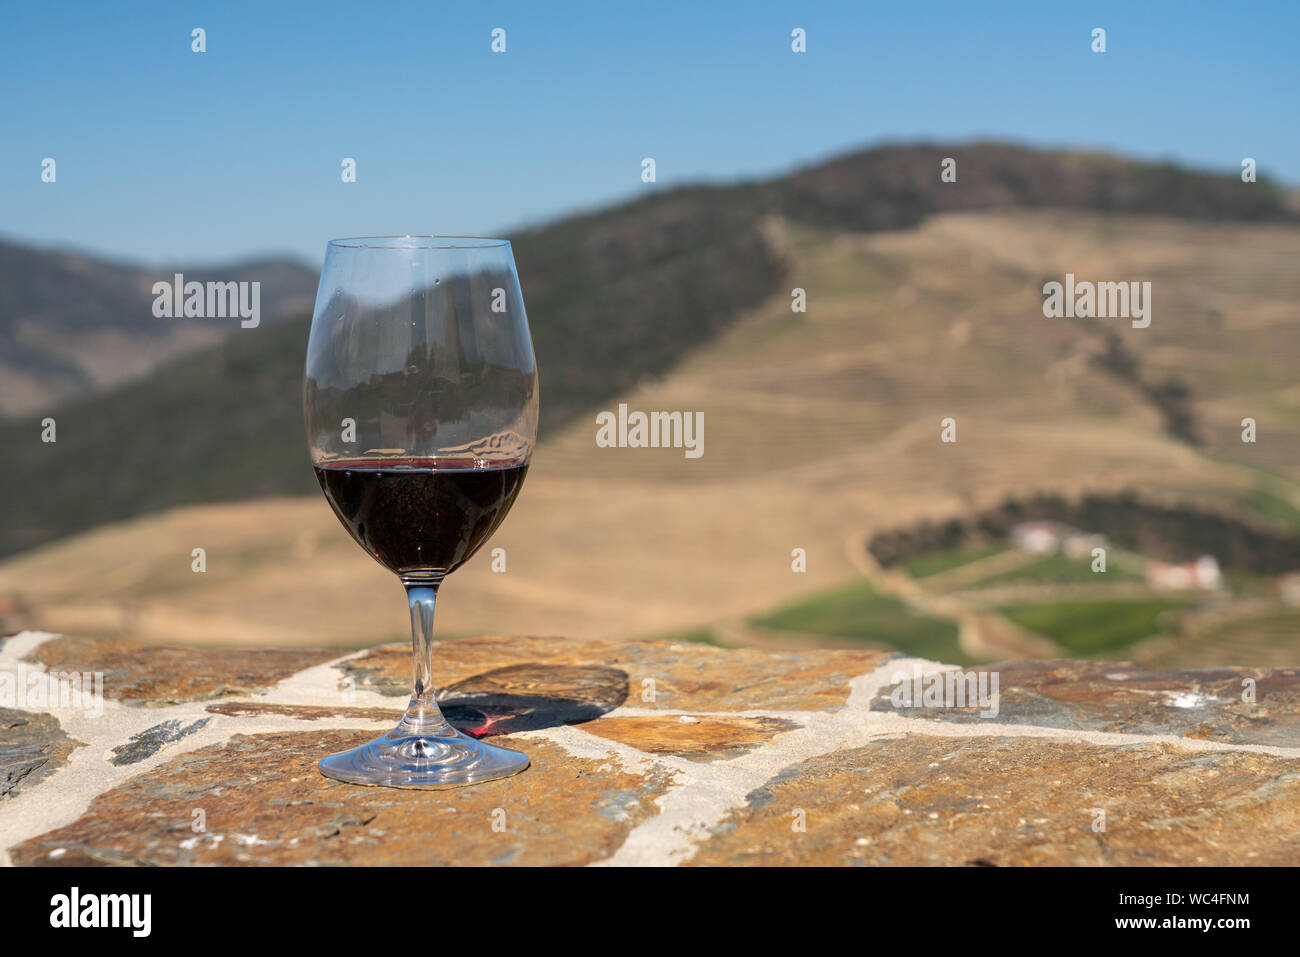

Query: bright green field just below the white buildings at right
<box><xmin>998</xmin><ymin>598</ymin><xmax>1188</xmax><ymax>657</ymax></box>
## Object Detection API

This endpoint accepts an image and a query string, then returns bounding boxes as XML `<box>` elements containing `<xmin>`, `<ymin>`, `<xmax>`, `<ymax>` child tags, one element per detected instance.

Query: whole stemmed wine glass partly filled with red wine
<box><xmin>303</xmin><ymin>235</ymin><xmax>537</xmax><ymax>788</ymax></box>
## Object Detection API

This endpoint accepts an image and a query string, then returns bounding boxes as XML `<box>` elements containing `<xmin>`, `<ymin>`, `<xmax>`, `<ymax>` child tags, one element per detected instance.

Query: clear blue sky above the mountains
<box><xmin>0</xmin><ymin>0</ymin><xmax>1300</xmax><ymax>264</ymax></box>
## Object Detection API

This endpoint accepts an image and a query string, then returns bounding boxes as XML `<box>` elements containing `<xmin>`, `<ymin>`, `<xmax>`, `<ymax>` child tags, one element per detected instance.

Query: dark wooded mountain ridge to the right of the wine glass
<box><xmin>512</xmin><ymin>143</ymin><xmax>1300</xmax><ymax>425</ymax></box>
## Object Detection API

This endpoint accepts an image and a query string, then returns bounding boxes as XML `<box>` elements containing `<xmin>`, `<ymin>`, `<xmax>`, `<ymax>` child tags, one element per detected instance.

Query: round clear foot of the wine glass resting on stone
<box><xmin>317</xmin><ymin>718</ymin><xmax>528</xmax><ymax>791</ymax></box>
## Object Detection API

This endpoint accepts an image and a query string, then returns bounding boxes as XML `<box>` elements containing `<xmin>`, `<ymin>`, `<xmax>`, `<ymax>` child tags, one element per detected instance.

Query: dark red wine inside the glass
<box><xmin>316</xmin><ymin>459</ymin><xmax>528</xmax><ymax>579</ymax></box>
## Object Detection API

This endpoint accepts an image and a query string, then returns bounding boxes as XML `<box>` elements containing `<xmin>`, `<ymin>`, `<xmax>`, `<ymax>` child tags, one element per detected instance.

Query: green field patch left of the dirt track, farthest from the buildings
<box><xmin>750</xmin><ymin>581</ymin><xmax>971</xmax><ymax>664</ymax></box>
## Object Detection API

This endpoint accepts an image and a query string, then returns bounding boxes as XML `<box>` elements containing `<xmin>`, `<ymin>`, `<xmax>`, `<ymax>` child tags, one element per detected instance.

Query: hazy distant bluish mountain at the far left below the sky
<box><xmin>0</xmin><ymin>241</ymin><xmax>316</xmax><ymax>416</ymax></box>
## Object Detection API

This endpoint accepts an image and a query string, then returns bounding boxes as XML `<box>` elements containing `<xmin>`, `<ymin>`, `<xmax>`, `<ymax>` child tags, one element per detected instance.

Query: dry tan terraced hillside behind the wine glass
<box><xmin>0</xmin><ymin>198</ymin><xmax>1300</xmax><ymax>667</ymax></box>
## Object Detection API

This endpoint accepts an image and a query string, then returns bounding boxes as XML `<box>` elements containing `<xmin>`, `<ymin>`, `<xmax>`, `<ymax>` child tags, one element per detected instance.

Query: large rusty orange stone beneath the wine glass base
<box><xmin>12</xmin><ymin>731</ymin><xmax>671</xmax><ymax>865</ymax></box>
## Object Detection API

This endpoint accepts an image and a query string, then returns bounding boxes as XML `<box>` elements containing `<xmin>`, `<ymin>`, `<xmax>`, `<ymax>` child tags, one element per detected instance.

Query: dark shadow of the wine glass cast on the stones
<box><xmin>438</xmin><ymin>664</ymin><xmax>628</xmax><ymax>737</ymax></box>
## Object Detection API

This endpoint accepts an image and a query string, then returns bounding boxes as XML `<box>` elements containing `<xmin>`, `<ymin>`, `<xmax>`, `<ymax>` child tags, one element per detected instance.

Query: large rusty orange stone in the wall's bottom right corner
<box><xmin>690</xmin><ymin>735</ymin><xmax>1300</xmax><ymax>866</ymax></box>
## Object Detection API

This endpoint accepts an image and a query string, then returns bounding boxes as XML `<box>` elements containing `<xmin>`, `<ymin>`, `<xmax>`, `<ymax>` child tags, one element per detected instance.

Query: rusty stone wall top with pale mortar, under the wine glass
<box><xmin>0</xmin><ymin>632</ymin><xmax>1300</xmax><ymax>865</ymax></box>
